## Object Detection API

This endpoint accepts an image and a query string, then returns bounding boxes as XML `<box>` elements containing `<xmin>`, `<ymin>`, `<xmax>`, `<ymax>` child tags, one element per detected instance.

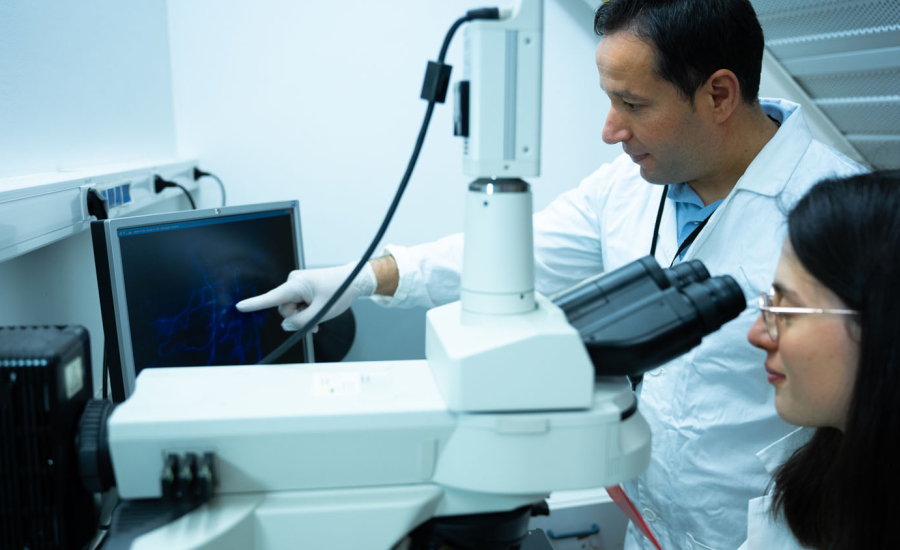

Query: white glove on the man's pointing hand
<box><xmin>236</xmin><ymin>262</ymin><xmax>378</xmax><ymax>330</ymax></box>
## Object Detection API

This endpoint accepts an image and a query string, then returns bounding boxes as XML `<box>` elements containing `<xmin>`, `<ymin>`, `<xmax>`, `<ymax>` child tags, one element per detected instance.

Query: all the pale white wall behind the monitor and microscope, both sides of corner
<box><xmin>0</xmin><ymin>0</ymin><xmax>617</xmax><ymax>385</ymax></box>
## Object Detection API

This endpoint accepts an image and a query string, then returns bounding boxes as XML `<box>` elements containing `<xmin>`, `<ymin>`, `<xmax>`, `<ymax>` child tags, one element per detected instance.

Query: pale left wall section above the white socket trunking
<box><xmin>0</xmin><ymin>0</ymin><xmax>175</xmax><ymax>178</ymax></box>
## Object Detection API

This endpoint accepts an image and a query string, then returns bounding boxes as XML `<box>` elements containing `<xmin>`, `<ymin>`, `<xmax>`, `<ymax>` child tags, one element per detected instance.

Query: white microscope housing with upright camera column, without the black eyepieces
<box><xmin>108</xmin><ymin>0</ymin><xmax>650</xmax><ymax>550</ymax></box>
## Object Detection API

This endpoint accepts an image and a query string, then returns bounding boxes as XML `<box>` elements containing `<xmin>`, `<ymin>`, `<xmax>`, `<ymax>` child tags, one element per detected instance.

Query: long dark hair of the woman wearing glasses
<box><xmin>773</xmin><ymin>172</ymin><xmax>900</xmax><ymax>550</ymax></box>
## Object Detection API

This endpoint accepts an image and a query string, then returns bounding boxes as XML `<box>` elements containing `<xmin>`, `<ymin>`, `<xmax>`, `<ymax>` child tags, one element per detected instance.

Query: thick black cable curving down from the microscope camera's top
<box><xmin>259</xmin><ymin>8</ymin><xmax>500</xmax><ymax>365</ymax></box>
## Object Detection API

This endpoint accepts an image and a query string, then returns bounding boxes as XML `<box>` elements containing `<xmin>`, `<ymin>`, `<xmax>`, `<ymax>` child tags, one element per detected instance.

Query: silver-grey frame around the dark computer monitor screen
<box><xmin>97</xmin><ymin>200</ymin><xmax>315</xmax><ymax>401</ymax></box>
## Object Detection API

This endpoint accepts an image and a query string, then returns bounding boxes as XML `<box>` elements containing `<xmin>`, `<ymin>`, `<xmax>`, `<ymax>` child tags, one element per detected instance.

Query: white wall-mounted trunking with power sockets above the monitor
<box><xmin>0</xmin><ymin>159</ymin><xmax>198</xmax><ymax>262</ymax></box>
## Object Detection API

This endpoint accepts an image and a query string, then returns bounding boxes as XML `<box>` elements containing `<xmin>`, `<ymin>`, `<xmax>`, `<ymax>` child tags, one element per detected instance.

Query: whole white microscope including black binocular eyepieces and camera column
<box><xmin>0</xmin><ymin>0</ymin><xmax>745</xmax><ymax>550</ymax></box>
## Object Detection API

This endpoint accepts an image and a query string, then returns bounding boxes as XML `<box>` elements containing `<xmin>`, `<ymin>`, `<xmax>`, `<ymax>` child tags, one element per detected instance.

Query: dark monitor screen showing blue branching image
<box><xmin>119</xmin><ymin>210</ymin><xmax>304</xmax><ymax>374</ymax></box>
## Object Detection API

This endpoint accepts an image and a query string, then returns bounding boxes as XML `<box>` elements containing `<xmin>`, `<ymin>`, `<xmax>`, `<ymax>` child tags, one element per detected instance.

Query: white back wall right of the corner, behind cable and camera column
<box><xmin>169</xmin><ymin>0</ymin><xmax>620</xmax><ymax>266</ymax></box>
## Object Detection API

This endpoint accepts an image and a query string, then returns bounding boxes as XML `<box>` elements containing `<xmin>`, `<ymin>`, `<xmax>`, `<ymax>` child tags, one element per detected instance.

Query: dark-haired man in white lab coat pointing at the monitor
<box><xmin>238</xmin><ymin>0</ymin><xmax>861</xmax><ymax>550</ymax></box>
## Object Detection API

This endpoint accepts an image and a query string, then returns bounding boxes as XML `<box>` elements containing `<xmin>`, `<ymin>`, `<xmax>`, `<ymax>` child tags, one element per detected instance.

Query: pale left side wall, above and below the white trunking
<box><xmin>0</xmin><ymin>0</ymin><xmax>184</xmax><ymax>396</ymax></box>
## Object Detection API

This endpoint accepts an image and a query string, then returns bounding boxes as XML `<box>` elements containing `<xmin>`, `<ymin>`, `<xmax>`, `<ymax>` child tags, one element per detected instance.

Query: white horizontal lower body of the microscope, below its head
<box><xmin>109</xmin><ymin>361</ymin><xmax>650</xmax><ymax>550</ymax></box>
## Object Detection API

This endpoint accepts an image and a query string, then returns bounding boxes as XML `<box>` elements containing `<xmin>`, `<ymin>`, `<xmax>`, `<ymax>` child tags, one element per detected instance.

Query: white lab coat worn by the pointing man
<box><xmin>376</xmin><ymin>100</ymin><xmax>862</xmax><ymax>550</ymax></box>
